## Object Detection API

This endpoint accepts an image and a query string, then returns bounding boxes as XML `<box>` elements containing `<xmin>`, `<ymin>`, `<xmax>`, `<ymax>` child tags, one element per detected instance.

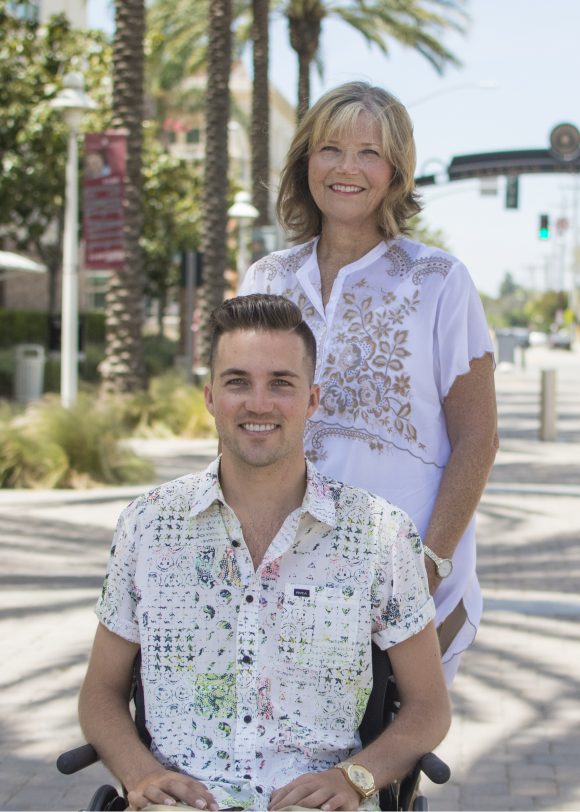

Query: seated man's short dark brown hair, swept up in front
<box><xmin>209</xmin><ymin>293</ymin><xmax>316</xmax><ymax>378</ymax></box>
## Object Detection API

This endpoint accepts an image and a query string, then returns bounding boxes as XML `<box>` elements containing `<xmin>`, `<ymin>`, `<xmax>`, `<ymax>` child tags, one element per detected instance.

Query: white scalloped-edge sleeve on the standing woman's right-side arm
<box><xmin>433</xmin><ymin>262</ymin><xmax>493</xmax><ymax>401</ymax></box>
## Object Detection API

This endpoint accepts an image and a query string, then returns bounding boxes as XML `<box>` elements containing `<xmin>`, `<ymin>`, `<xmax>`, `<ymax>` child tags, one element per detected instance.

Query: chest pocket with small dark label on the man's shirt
<box><xmin>278</xmin><ymin>584</ymin><xmax>360</xmax><ymax>669</ymax></box>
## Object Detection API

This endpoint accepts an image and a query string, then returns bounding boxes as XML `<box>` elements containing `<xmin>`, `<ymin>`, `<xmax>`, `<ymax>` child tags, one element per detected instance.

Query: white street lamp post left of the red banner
<box><xmin>50</xmin><ymin>73</ymin><xmax>96</xmax><ymax>409</ymax></box>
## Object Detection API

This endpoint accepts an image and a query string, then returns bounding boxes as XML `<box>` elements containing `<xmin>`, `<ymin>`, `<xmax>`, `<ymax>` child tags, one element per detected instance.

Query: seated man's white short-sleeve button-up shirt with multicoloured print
<box><xmin>97</xmin><ymin>460</ymin><xmax>434</xmax><ymax>809</ymax></box>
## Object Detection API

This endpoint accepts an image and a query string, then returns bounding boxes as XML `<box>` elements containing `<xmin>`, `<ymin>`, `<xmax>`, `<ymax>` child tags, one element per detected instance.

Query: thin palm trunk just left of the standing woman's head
<box><xmin>251</xmin><ymin>0</ymin><xmax>270</xmax><ymax>226</ymax></box>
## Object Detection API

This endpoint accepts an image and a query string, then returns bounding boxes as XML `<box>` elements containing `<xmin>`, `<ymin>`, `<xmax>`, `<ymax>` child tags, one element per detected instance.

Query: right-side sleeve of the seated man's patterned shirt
<box><xmin>371</xmin><ymin>505</ymin><xmax>435</xmax><ymax>650</ymax></box>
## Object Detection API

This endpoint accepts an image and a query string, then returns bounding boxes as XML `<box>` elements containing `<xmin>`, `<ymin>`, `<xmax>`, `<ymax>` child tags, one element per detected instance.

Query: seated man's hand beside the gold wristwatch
<box><xmin>268</xmin><ymin>769</ymin><xmax>360</xmax><ymax>810</ymax></box>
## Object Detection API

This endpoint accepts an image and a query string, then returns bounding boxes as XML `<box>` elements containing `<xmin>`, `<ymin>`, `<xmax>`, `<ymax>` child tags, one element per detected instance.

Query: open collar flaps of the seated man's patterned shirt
<box><xmin>190</xmin><ymin>457</ymin><xmax>340</xmax><ymax>527</ymax></box>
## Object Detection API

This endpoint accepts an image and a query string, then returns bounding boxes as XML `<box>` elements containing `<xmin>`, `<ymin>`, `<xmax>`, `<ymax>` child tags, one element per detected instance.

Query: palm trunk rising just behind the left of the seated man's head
<box><xmin>198</xmin><ymin>0</ymin><xmax>232</xmax><ymax>365</ymax></box>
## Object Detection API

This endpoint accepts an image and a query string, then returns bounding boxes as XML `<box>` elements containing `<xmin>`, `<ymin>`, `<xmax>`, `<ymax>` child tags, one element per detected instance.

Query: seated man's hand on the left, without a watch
<box><xmin>127</xmin><ymin>769</ymin><xmax>219</xmax><ymax>810</ymax></box>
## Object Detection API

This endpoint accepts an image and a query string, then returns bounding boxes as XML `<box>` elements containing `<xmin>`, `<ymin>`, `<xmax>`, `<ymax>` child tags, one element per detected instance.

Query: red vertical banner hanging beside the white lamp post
<box><xmin>83</xmin><ymin>133</ymin><xmax>127</xmax><ymax>270</ymax></box>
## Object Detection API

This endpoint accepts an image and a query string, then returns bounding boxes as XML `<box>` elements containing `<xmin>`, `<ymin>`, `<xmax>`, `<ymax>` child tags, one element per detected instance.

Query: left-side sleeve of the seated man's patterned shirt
<box><xmin>95</xmin><ymin>506</ymin><xmax>140</xmax><ymax>643</ymax></box>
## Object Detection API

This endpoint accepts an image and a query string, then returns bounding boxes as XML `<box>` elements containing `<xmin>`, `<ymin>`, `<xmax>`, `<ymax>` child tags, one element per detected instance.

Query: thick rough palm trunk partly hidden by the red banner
<box><xmin>101</xmin><ymin>0</ymin><xmax>145</xmax><ymax>392</ymax></box>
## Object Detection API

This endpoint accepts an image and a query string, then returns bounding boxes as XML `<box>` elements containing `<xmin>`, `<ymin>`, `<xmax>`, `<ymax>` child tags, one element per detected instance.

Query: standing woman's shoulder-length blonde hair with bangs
<box><xmin>276</xmin><ymin>82</ymin><xmax>421</xmax><ymax>242</ymax></box>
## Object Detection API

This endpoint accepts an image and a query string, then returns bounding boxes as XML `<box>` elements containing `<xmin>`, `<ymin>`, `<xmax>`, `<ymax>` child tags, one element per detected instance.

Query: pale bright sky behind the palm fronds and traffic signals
<box><xmin>88</xmin><ymin>0</ymin><xmax>580</xmax><ymax>296</ymax></box>
